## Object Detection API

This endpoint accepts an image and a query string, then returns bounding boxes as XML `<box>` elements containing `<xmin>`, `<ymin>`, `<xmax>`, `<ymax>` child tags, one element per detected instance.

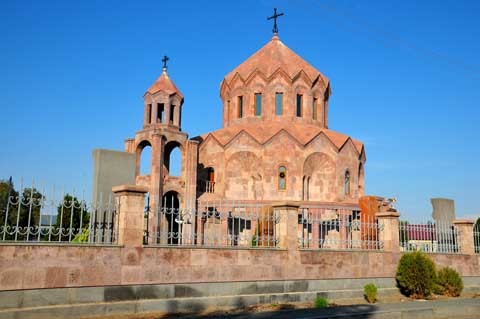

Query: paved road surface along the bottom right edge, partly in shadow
<box><xmin>174</xmin><ymin>298</ymin><xmax>480</xmax><ymax>319</ymax></box>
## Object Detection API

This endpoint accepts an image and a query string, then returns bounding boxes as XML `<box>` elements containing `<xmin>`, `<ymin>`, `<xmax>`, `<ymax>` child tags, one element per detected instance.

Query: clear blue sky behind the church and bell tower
<box><xmin>0</xmin><ymin>0</ymin><xmax>480</xmax><ymax>218</ymax></box>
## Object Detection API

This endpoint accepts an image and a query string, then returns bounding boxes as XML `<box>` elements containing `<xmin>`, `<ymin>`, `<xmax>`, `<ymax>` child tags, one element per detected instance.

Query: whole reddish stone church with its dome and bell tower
<box><xmin>125</xmin><ymin>33</ymin><xmax>366</xmax><ymax>218</ymax></box>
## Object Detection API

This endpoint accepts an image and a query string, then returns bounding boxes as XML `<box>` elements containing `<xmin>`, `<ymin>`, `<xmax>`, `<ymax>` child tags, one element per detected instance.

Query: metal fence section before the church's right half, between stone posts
<box><xmin>298</xmin><ymin>206</ymin><xmax>384</xmax><ymax>250</ymax></box>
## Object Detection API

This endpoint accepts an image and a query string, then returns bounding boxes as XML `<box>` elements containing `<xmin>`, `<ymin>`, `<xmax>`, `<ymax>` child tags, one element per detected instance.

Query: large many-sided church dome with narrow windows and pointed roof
<box><xmin>220</xmin><ymin>34</ymin><xmax>330</xmax><ymax>128</ymax></box>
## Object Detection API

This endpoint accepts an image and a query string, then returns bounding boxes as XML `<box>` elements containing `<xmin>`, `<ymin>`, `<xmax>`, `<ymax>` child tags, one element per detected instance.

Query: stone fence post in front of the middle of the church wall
<box><xmin>272</xmin><ymin>202</ymin><xmax>300</xmax><ymax>250</ymax></box>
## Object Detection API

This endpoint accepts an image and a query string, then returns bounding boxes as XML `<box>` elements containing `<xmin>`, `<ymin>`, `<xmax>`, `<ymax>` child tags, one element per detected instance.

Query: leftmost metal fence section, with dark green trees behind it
<box><xmin>0</xmin><ymin>181</ymin><xmax>117</xmax><ymax>244</ymax></box>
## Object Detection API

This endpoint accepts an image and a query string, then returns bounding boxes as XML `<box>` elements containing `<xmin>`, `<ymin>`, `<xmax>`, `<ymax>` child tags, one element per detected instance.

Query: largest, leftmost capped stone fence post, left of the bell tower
<box><xmin>112</xmin><ymin>185</ymin><xmax>148</xmax><ymax>247</ymax></box>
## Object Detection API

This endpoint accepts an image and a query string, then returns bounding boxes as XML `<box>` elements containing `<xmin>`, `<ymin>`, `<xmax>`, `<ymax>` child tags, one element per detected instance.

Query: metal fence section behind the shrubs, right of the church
<box><xmin>399</xmin><ymin>221</ymin><xmax>460</xmax><ymax>253</ymax></box>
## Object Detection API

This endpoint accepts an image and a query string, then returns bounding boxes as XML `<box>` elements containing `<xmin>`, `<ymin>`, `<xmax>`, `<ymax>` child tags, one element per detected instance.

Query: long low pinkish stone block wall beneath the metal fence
<box><xmin>0</xmin><ymin>244</ymin><xmax>480</xmax><ymax>291</ymax></box>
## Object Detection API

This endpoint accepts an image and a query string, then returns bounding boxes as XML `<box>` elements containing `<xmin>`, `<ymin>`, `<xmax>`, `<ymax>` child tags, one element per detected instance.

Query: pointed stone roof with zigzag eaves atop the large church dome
<box><xmin>224</xmin><ymin>35</ymin><xmax>328</xmax><ymax>87</ymax></box>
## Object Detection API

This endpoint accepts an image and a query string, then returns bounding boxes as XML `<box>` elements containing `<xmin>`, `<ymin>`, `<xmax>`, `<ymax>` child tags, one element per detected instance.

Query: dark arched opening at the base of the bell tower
<box><xmin>162</xmin><ymin>191</ymin><xmax>181</xmax><ymax>245</ymax></box>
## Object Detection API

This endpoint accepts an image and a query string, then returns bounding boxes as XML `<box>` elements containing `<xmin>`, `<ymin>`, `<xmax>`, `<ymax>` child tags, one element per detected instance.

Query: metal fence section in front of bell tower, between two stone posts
<box><xmin>144</xmin><ymin>201</ymin><xmax>280</xmax><ymax>248</ymax></box>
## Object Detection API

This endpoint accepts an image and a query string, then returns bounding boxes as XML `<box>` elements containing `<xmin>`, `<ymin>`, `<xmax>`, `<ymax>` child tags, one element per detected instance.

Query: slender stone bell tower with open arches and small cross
<box><xmin>125</xmin><ymin>56</ymin><xmax>198</xmax><ymax>243</ymax></box>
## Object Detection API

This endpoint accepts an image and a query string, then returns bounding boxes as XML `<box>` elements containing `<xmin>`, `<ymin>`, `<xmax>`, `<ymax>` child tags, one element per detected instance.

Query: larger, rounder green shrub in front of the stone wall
<box><xmin>395</xmin><ymin>251</ymin><xmax>436</xmax><ymax>299</ymax></box>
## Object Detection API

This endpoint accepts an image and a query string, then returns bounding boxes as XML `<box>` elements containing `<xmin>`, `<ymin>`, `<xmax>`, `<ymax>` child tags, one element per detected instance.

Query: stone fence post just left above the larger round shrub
<box><xmin>375</xmin><ymin>212</ymin><xmax>400</xmax><ymax>252</ymax></box>
